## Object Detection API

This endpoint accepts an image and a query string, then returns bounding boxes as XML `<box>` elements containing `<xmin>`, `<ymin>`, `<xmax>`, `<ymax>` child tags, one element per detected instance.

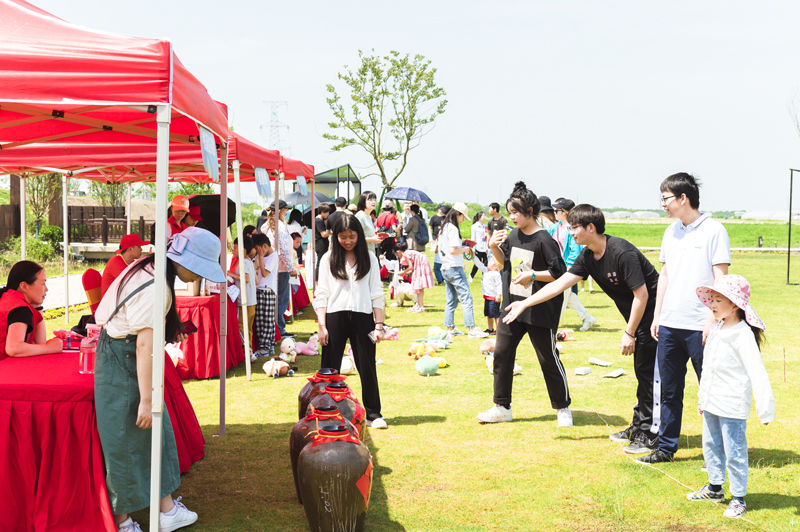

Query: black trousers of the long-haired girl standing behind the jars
<box><xmin>320</xmin><ymin>310</ymin><xmax>382</xmax><ymax>420</ymax></box>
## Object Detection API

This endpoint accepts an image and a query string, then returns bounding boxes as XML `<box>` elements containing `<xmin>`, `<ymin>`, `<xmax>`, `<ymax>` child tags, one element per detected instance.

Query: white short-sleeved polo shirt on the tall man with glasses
<box><xmin>658</xmin><ymin>214</ymin><xmax>731</xmax><ymax>331</ymax></box>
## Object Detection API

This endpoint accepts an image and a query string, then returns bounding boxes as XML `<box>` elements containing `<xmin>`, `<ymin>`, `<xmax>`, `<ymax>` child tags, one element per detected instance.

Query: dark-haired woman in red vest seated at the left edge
<box><xmin>0</xmin><ymin>260</ymin><xmax>61</xmax><ymax>360</ymax></box>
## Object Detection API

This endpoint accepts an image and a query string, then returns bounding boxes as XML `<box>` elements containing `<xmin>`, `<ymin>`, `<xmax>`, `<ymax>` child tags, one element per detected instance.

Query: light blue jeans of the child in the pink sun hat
<box><xmin>703</xmin><ymin>412</ymin><xmax>747</xmax><ymax>497</ymax></box>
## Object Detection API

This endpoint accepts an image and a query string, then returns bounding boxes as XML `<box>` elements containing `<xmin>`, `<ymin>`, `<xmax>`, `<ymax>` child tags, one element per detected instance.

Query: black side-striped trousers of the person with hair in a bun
<box><xmin>494</xmin><ymin>320</ymin><xmax>572</xmax><ymax>409</ymax></box>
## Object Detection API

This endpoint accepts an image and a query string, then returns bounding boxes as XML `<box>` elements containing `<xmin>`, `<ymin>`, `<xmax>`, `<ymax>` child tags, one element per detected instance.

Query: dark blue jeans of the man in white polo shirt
<box><xmin>650</xmin><ymin>325</ymin><xmax>703</xmax><ymax>456</ymax></box>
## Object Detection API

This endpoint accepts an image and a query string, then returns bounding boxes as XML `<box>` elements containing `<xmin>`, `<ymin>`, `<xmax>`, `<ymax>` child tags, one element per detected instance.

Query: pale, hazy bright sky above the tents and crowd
<box><xmin>28</xmin><ymin>0</ymin><xmax>800</xmax><ymax>210</ymax></box>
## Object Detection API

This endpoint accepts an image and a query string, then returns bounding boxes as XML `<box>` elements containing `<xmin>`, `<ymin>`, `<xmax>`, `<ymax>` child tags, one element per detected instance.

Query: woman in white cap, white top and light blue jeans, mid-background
<box><xmin>438</xmin><ymin>202</ymin><xmax>489</xmax><ymax>338</ymax></box>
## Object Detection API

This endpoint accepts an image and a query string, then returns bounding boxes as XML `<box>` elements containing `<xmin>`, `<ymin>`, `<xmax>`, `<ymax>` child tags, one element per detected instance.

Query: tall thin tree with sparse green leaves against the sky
<box><xmin>323</xmin><ymin>50</ymin><xmax>447</xmax><ymax>190</ymax></box>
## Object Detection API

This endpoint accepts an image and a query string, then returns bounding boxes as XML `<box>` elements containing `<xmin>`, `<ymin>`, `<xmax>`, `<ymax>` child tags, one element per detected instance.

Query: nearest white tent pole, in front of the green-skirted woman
<box><xmin>150</xmin><ymin>104</ymin><xmax>172</xmax><ymax>532</ymax></box>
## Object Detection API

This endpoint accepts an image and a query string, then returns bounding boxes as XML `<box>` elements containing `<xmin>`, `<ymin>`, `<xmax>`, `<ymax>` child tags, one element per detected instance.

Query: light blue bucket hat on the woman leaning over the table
<box><xmin>167</xmin><ymin>227</ymin><xmax>225</xmax><ymax>283</ymax></box>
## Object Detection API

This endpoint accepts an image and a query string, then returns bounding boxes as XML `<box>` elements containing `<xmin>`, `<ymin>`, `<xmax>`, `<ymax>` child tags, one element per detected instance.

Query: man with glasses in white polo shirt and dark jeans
<box><xmin>637</xmin><ymin>172</ymin><xmax>731</xmax><ymax>464</ymax></box>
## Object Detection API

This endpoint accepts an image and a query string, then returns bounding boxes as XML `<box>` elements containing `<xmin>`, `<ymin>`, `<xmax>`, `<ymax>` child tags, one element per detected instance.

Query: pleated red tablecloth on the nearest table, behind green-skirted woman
<box><xmin>0</xmin><ymin>353</ymin><xmax>205</xmax><ymax>532</ymax></box>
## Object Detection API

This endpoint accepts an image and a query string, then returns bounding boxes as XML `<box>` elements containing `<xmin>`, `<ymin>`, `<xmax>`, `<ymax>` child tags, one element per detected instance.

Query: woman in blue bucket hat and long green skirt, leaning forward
<box><xmin>94</xmin><ymin>227</ymin><xmax>225</xmax><ymax>532</ymax></box>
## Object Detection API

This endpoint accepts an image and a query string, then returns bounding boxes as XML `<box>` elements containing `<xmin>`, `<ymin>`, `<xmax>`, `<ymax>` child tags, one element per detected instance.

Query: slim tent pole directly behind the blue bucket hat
<box><xmin>219</xmin><ymin>145</ymin><xmax>228</xmax><ymax>436</ymax></box>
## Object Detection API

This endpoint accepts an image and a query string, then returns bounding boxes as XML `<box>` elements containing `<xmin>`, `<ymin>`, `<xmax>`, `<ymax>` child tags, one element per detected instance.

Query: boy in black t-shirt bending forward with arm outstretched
<box><xmin>503</xmin><ymin>204</ymin><xmax>658</xmax><ymax>454</ymax></box>
